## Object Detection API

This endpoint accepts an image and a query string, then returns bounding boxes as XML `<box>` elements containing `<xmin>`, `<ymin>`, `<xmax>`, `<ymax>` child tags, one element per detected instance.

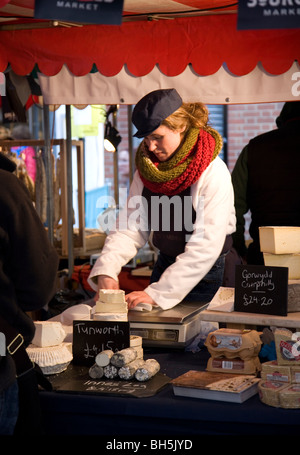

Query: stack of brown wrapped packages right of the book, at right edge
<box><xmin>258</xmin><ymin>329</ymin><xmax>300</xmax><ymax>409</ymax></box>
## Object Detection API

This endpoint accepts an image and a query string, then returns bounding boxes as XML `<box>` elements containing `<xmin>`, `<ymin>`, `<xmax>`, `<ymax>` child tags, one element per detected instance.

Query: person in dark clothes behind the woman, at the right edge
<box><xmin>232</xmin><ymin>101</ymin><xmax>300</xmax><ymax>265</ymax></box>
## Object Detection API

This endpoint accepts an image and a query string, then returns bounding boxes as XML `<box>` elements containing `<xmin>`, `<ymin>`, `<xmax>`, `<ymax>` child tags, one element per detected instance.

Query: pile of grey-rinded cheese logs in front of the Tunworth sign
<box><xmin>89</xmin><ymin>335</ymin><xmax>160</xmax><ymax>382</ymax></box>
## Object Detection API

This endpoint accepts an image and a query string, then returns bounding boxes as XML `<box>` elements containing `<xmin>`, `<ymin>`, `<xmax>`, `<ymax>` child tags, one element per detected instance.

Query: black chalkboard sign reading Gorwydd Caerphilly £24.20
<box><xmin>234</xmin><ymin>265</ymin><xmax>288</xmax><ymax>316</ymax></box>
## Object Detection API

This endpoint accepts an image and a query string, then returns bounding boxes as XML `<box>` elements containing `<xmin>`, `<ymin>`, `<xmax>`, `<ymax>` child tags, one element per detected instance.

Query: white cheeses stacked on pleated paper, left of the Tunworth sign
<box><xmin>27</xmin><ymin>321</ymin><xmax>73</xmax><ymax>375</ymax></box>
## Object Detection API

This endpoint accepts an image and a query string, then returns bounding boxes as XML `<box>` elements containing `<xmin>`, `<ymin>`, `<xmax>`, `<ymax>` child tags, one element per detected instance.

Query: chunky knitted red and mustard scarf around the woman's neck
<box><xmin>136</xmin><ymin>128</ymin><xmax>222</xmax><ymax>196</ymax></box>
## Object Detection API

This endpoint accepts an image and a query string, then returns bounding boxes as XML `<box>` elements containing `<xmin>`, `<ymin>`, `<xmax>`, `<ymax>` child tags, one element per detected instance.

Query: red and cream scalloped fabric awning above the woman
<box><xmin>0</xmin><ymin>0</ymin><xmax>300</xmax><ymax>104</ymax></box>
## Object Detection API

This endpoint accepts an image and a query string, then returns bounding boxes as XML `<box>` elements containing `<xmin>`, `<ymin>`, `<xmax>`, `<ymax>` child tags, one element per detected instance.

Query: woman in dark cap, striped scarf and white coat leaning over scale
<box><xmin>89</xmin><ymin>89</ymin><xmax>236</xmax><ymax>310</ymax></box>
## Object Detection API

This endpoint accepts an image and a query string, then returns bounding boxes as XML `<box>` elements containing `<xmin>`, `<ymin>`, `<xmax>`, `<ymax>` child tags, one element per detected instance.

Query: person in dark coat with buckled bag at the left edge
<box><xmin>0</xmin><ymin>153</ymin><xmax>58</xmax><ymax>435</ymax></box>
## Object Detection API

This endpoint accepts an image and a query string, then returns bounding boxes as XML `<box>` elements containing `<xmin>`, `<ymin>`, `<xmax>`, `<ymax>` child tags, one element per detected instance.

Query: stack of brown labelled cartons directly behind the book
<box><xmin>204</xmin><ymin>328</ymin><xmax>262</xmax><ymax>375</ymax></box>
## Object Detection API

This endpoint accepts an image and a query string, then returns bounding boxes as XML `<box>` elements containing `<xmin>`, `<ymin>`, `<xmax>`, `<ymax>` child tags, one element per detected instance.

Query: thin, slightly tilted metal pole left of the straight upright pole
<box><xmin>43</xmin><ymin>104</ymin><xmax>54</xmax><ymax>245</ymax></box>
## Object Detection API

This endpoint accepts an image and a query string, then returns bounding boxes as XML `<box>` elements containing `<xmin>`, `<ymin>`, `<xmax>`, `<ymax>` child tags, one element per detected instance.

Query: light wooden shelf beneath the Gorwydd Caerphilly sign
<box><xmin>200</xmin><ymin>310</ymin><xmax>300</xmax><ymax>329</ymax></box>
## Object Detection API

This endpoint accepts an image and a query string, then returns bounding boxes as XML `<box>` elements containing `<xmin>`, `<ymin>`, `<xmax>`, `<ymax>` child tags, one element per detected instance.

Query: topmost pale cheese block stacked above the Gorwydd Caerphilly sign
<box><xmin>259</xmin><ymin>226</ymin><xmax>300</xmax><ymax>254</ymax></box>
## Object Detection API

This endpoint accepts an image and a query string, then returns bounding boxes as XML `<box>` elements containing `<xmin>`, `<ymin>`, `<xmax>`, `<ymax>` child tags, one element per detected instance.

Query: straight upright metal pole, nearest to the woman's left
<box><xmin>66</xmin><ymin>105</ymin><xmax>74</xmax><ymax>278</ymax></box>
